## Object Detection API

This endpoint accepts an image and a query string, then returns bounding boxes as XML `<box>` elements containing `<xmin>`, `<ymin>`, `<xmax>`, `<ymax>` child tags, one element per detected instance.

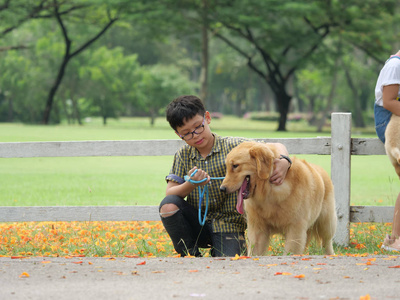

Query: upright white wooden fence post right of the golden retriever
<box><xmin>331</xmin><ymin>113</ymin><xmax>351</xmax><ymax>246</ymax></box>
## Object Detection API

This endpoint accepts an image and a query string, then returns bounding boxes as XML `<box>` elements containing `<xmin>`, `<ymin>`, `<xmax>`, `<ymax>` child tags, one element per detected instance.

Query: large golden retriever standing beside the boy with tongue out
<box><xmin>221</xmin><ymin>142</ymin><xmax>337</xmax><ymax>256</ymax></box>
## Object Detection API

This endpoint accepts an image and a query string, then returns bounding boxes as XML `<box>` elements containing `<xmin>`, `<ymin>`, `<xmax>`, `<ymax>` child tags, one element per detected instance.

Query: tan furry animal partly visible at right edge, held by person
<box><xmin>385</xmin><ymin>114</ymin><xmax>400</xmax><ymax>177</ymax></box>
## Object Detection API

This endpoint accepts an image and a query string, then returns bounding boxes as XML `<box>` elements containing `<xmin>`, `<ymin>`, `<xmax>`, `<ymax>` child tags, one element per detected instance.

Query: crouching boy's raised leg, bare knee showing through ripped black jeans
<box><xmin>159</xmin><ymin>195</ymin><xmax>211</xmax><ymax>256</ymax></box>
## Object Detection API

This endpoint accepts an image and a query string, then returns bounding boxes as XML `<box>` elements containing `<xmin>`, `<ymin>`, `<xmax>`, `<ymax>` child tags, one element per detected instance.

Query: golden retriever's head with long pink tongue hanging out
<box><xmin>220</xmin><ymin>142</ymin><xmax>274</xmax><ymax>214</ymax></box>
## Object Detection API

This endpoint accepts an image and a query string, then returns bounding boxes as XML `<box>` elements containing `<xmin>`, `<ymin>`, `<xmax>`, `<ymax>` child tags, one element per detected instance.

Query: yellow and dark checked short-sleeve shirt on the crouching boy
<box><xmin>166</xmin><ymin>133</ymin><xmax>249</xmax><ymax>233</ymax></box>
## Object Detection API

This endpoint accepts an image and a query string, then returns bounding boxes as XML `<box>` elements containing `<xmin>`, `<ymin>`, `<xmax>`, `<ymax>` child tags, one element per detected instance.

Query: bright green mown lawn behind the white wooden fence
<box><xmin>0</xmin><ymin>116</ymin><xmax>400</xmax><ymax>206</ymax></box>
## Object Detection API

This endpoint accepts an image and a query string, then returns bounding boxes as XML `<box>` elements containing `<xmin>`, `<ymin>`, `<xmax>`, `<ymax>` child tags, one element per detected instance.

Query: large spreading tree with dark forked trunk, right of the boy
<box><xmin>166</xmin><ymin>0</ymin><xmax>395</xmax><ymax>130</ymax></box>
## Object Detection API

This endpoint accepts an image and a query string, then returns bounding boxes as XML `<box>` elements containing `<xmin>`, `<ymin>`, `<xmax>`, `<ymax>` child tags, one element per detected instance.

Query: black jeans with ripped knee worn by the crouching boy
<box><xmin>159</xmin><ymin>195</ymin><xmax>246</xmax><ymax>257</ymax></box>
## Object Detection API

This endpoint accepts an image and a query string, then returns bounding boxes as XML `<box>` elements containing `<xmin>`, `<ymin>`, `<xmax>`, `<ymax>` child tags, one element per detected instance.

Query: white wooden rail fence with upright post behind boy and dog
<box><xmin>0</xmin><ymin>113</ymin><xmax>394</xmax><ymax>245</ymax></box>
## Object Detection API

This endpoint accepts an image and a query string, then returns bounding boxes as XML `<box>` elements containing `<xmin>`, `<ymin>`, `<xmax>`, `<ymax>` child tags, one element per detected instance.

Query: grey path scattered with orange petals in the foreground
<box><xmin>0</xmin><ymin>256</ymin><xmax>400</xmax><ymax>300</ymax></box>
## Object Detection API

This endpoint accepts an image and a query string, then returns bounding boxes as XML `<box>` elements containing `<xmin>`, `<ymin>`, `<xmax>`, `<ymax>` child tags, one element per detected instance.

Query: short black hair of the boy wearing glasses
<box><xmin>167</xmin><ymin>95</ymin><xmax>206</xmax><ymax>131</ymax></box>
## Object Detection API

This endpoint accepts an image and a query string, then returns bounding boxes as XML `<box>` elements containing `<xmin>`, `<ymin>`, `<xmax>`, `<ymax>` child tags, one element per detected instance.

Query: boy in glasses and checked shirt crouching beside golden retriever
<box><xmin>160</xmin><ymin>96</ymin><xmax>291</xmax><ymax>256</ymax></box>
